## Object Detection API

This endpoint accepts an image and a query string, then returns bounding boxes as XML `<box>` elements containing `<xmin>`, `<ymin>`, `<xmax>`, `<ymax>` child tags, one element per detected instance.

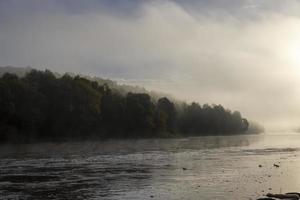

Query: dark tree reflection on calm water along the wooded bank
<box><xmin>0</xmin><ymin>135</ymin><xmax>260</xmax><ymax>158</ymax></box>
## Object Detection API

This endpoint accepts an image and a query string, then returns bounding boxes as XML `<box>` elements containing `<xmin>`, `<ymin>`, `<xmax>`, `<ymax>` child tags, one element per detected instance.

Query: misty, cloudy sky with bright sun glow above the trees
<box><xmin>0</xmin><ymin>0</ymin><xmax>300</xmax><ymax>130</ymax></box>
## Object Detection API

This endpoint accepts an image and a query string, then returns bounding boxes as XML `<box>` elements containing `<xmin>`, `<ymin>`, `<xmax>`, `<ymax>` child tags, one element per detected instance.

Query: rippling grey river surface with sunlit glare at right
<box><xmin>0</xmin><ymin>133</ymin><xmax>300</xmax><ymax>200</ymax></box>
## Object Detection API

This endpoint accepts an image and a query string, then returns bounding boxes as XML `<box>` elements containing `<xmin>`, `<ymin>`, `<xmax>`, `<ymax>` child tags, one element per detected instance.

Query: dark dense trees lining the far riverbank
<box><xmin>0</xmin><ymin>70</ymin><xmax>248</xmax><ymax>142</ymax></box>
